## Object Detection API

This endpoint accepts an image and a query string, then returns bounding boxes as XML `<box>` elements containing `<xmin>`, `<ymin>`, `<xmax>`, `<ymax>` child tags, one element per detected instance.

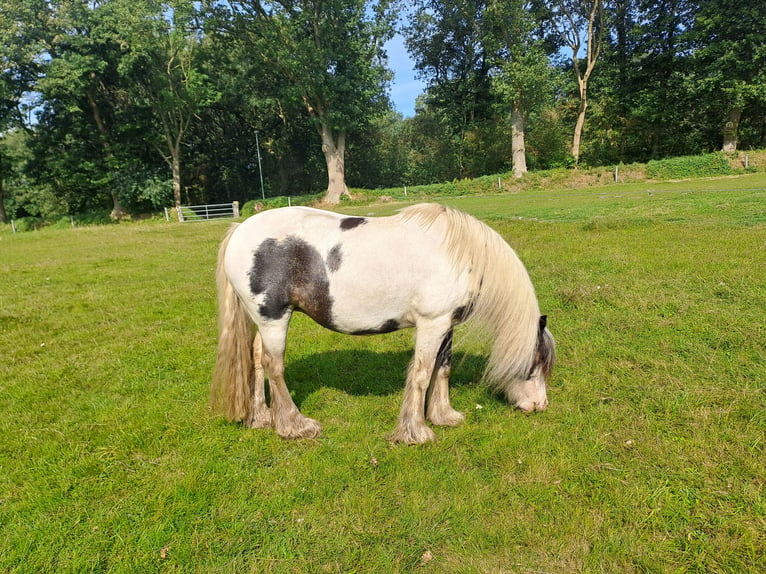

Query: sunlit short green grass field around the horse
<box><xmin>0</xmin><ymin>175</ymin><xmax>766</xmax><ymax>573</ymax></box>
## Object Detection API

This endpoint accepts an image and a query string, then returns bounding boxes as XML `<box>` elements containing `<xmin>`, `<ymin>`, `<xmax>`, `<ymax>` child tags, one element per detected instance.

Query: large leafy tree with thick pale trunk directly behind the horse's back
<box><xmin>214</xmin><ymin>0</ymin><xmax>395</xmax><ymax>204</ymax></box>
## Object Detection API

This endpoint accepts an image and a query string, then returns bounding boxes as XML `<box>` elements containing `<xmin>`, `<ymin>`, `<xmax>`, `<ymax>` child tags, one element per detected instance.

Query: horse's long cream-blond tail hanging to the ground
<box><xmin>210</xmin><ymin>223</ymin><xmax>255</xmax><ymax>421</ymax></box>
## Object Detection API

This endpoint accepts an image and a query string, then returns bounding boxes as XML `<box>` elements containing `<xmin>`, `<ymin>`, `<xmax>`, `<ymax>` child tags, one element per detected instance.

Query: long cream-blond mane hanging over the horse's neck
<box><xmin>399</xmin><ymin>203</ymin><xmax>540</xmax><ymax>390</ymax></box>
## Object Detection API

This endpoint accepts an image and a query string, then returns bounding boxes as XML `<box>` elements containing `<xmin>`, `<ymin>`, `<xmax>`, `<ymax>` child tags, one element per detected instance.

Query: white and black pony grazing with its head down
<box><xmin>212</xmin><ymin>204</ymin><xmax>555</xmax><ymax>444</ymax></box>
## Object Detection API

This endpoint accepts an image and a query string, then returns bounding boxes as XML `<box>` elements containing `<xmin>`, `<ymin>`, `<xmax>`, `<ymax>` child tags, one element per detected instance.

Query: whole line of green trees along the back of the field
<box><xmin>0</xmin><ymin>0</ymin><xmax>766</xmax><ymax>221</ymax></box>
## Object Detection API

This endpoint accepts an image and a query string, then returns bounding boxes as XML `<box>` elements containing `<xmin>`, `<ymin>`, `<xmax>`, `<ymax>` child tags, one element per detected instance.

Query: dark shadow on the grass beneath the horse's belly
<box><xmin>285</xmin><ymin>349</ymin><xmax>485</xmax><ymax>406</ymax></box>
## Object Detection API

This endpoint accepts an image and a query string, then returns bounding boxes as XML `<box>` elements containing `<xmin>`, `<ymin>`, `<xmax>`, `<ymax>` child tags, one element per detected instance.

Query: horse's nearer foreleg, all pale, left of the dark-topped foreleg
<box><xmin>390</xmin><ymin>325</ymin><xmax>449</xmax><ymax>444</ymax></box>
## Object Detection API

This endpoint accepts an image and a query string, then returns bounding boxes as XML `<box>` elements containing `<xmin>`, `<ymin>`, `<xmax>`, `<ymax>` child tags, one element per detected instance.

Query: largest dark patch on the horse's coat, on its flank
<box><xmin>248</xmin><ymin>236</ymin><xmax>333</xmax><ymax>329</ymax></box>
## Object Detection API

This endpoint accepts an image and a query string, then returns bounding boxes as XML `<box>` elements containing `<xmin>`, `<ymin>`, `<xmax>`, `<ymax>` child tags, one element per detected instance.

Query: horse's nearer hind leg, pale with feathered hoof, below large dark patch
<box><xmin>260</xmin><ymin>320</ymin><xmax>322</xmax><ymax>438</ymax></box>
